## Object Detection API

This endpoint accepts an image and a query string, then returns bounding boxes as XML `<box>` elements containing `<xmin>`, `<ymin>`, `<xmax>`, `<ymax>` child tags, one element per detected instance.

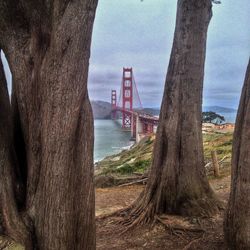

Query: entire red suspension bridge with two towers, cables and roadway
<box><xmin>111</xmin><ymin>68</ymin><xmax>159</xmax><ymax>142</ymax></box>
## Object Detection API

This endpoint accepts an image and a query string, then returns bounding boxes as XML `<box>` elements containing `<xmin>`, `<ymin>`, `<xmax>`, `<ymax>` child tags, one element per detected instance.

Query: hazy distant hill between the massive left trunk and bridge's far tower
<box><xmin>91</xmin><ymin>101</ymin><xmax>111</xmax><ymax>119</ymax></box>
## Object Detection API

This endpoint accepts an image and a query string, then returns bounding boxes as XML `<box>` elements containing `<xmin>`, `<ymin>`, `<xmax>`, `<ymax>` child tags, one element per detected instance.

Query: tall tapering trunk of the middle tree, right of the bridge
<box><xmin>120</xmin><ymin>0</ymin><xmax>219</xmax><ymax>227</ymax></box>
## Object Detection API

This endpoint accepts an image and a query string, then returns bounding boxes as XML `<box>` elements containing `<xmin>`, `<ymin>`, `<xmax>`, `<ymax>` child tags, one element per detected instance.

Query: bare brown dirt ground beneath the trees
<box><xmin>96</xmin><ymin>177</ymin><xmax>230</xmax><ymax>250</ymax></box>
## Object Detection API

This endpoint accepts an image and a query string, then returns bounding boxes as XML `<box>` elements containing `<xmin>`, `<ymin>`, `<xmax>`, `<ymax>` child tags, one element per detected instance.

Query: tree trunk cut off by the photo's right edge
<box><xmin>224</xmin><ymin>61</ymin><xmax>250</xmax><ymax>250</ymax></box>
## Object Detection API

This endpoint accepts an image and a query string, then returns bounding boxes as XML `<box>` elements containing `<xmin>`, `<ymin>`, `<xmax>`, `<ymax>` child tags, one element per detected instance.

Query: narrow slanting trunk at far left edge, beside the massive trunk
<box><xmin>0</xmin><ymin>50</ymin><xmax>32</xmax><ymax>249</ymax></box>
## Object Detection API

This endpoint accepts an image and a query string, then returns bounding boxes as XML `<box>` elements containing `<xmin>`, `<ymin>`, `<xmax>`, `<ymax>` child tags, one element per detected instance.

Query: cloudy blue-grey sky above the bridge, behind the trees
<box><xmin>89</xmin><ymin>0</ymin><xmax>250</xmax><ymax>108</ymax></box>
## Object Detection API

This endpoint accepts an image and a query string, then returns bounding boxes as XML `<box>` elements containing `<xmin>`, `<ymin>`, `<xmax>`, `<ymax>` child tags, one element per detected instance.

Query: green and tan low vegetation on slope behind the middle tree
<box><xmin>95</xmin><ymin>129</ymin><xmax>233</xmax><ymax>183</ymax></box>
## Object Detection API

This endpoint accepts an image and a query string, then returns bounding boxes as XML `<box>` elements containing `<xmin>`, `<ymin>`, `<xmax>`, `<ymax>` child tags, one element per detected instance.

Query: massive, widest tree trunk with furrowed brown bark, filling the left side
<box><xmin>0</xmin><ymin>0</ymin><xmax>98</xmax><ymax>250</ymax></box>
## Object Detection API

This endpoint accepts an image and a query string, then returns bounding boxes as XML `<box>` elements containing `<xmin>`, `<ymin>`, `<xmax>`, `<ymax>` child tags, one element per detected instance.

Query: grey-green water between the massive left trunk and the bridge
<box><xmin>94</xmin><ymin>120</ymin><xmax>134</xmax><ymax>162</ymax></box>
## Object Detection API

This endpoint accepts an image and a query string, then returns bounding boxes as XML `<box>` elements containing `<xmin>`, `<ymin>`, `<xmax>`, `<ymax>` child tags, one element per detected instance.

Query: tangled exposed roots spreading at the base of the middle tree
<box><xmin>107</xmin><ymin>188</ymin><xmax>224</xmax><ymax>234</ymax></box>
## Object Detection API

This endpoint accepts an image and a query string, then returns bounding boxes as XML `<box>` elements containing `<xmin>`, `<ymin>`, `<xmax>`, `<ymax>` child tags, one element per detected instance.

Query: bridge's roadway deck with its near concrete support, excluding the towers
<box><xmin>112</xmin><ymin>107</ymin><xmax>159</xmax><ymax>142</ymax></box>
